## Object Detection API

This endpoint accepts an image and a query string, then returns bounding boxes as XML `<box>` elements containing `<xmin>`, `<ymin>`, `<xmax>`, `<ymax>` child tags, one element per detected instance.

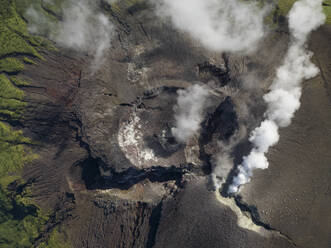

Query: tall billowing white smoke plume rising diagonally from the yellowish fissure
<box><xmin>228</xmin><ymin>0</ymin><xmax>325</xmax><ymax>193</ymax></box>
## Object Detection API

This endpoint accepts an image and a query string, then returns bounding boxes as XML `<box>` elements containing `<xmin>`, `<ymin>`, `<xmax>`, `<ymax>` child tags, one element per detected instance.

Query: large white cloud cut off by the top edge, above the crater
<box><xmin>157</xmin><ymin>0</ymin><xmax>268</xmax><ymax>52</ymax></box>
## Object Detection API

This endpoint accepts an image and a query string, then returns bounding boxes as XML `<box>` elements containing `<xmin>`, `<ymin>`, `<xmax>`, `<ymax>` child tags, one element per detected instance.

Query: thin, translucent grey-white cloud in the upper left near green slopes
<box><xmin>27</xmin><ymin>0</ymin><xmax>114</xmax><ymax>71</ymax></box>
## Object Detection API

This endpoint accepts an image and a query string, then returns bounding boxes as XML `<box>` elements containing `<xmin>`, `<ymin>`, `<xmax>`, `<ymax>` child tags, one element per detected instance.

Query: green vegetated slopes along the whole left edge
<box><xmin>0</xmin><ymin>0</ymin><xmax>69</xmax><ymax>248</ymax></box>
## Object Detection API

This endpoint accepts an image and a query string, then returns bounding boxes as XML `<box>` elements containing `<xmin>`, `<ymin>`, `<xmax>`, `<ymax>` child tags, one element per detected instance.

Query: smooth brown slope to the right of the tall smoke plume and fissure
<box><xmin>242</xmin><ymin>27</ymin><xmax>331</xmax><ymax>248</ymax></box>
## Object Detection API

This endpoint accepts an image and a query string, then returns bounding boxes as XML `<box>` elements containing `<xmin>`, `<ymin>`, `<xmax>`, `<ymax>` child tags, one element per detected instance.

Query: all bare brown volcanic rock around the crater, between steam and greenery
<box><xmin>16</xmin><ymin>1</ymin><xmax>331</xmax><ymax>248</ymax></box>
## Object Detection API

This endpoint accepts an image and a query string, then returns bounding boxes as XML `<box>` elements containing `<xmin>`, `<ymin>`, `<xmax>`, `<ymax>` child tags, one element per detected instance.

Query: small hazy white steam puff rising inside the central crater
<box><xmin>171</xmin><ymin>84</ymin><xmax>209</xmax><ymax>143</ymax></box>
